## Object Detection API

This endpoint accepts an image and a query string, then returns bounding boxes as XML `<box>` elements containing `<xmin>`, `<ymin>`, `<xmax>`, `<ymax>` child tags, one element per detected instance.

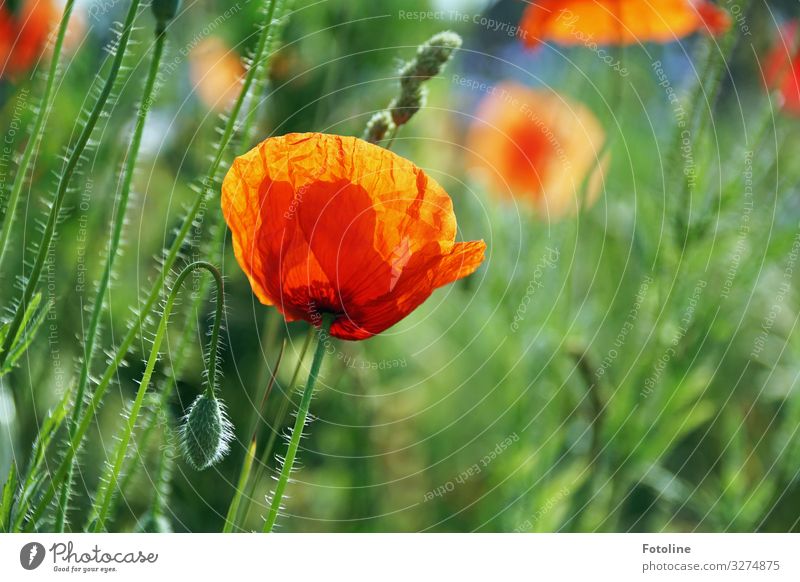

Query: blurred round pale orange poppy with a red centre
<box><xmin>467</xmin><ymin>83</ymin><xmax>608</xmax><ymax>217</ymax></box>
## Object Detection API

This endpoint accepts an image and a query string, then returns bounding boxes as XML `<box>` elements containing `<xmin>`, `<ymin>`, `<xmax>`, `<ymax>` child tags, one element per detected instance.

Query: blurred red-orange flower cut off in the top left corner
<box><xmin>0</xmin><ymin>0</ymin><xmax>60</xmax><ymax>78</ymax></box>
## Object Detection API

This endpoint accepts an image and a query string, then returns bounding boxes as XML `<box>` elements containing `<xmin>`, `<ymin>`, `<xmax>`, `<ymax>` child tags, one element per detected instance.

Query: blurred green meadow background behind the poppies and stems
<box><xmin>0</xmin><ymin>0</ymin><xmax>800</xmax><ymax>532</ymax></box>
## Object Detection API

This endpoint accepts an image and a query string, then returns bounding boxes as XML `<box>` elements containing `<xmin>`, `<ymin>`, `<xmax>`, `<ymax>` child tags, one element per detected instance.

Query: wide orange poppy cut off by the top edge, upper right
<box><xmin>520</xmin><ymin>0</ymin><xmax>731</xmax><ymax>47</ymax></box>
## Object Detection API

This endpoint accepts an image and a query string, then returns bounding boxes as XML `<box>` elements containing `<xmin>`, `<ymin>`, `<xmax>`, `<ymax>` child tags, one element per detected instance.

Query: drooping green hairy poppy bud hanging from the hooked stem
<box><xmin>180</xmin><ymin>394</ymin><xmax>232</xmax><ymax>471</ymax></box>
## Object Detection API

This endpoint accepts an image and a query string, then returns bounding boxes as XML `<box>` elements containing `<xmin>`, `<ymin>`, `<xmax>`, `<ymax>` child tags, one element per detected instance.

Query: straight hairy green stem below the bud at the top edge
<box><xmin>55</xmin><ymin>21</ymin><xmax>167</xmax><ymax>532</ymax></box>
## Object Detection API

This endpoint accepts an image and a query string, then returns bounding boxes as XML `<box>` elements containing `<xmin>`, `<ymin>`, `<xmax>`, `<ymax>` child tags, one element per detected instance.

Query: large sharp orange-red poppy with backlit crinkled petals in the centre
<box><xmin>222</xmin><ymin>133</ymin><xmax>486</xmax><ymax>340</ymax></box>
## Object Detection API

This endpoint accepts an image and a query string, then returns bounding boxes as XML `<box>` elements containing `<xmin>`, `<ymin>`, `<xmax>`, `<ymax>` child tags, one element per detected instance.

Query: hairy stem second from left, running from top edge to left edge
<box><xmin>0</xmin><ymin>0</ymin><xmax>141</xmax><ymax>368</ymax></box>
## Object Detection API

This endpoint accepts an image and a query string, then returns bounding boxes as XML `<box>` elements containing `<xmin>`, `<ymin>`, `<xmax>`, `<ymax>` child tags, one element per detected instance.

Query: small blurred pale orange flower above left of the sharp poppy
<box><xmin>189</xmin><ymin>37</ymin><xmax>247</xmax><ymax>111</ymax></box>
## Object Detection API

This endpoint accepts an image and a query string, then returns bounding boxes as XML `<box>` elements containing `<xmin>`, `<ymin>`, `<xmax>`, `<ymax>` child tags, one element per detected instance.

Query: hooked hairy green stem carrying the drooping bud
<box><xmin>90</xmin><ymin>261</ymin><xmax>225</xmax><ymax>532</ymax></box>
